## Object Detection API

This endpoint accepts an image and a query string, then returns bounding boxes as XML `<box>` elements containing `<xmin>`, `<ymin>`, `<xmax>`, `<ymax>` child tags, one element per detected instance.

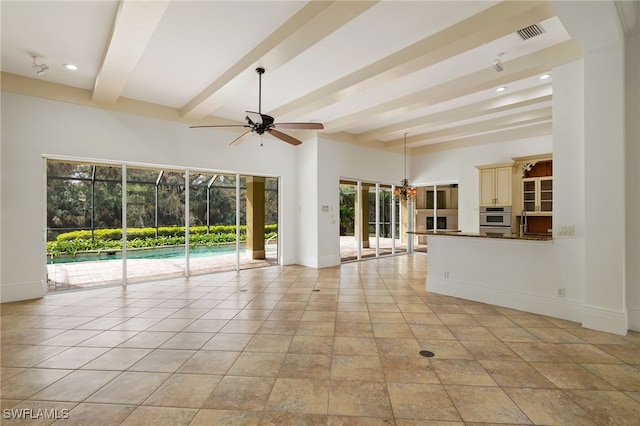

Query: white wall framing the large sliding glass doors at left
<box><xmin>0</xmin><ymin>92</ymin><xmax>297</xmax><ymax>302</ymax></box>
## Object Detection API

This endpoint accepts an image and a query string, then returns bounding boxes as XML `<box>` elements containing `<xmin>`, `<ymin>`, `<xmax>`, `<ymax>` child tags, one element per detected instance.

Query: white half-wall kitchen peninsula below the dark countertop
<box><xmin>426</xmin><ymin>232</ymin><xmax>579</xmax><ymax>319</ymax></box>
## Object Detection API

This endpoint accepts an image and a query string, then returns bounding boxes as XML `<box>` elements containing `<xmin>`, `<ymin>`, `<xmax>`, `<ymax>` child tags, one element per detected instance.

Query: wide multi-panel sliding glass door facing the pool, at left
<box><xmin>45</xmin><ymin>159</ymin><xmax>279</xmax><ymax>291</ymax></box>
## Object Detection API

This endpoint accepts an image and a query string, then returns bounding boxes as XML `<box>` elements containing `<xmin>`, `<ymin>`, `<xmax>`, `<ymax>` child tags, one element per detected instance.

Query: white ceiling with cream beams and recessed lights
<box><xmin>1</xmin><ymin>0</ymin><xmax>608</xmax><ymax>150</ymax></box>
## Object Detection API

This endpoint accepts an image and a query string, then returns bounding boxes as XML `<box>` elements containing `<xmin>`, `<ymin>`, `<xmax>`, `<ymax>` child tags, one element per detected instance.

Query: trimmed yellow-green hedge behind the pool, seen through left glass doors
<box><xmin>47</xmin><ymin>225</ymin><xmax>278</xmax><ymax>256</ymax></box>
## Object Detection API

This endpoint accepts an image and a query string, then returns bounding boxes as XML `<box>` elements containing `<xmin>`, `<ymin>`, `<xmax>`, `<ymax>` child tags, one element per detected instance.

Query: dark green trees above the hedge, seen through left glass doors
<box><xmin>47</xmin><ymin>160</ymin><xmax>278</xmax><ymax>241</ymax></box>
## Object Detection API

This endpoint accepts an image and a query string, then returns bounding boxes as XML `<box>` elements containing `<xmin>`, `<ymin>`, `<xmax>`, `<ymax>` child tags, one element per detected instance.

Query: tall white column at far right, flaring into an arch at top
<box><xmin>552</xmin><ymin>1</ymin><xmax>640</xmax><ymax>330</ymax></box>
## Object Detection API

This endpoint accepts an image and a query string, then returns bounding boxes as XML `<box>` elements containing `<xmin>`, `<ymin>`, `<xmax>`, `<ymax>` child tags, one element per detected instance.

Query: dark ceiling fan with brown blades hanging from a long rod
<box><xmin>190</xmin><ymin>67</ymin><xmax>324</xmax><ymax>146</ymax></box>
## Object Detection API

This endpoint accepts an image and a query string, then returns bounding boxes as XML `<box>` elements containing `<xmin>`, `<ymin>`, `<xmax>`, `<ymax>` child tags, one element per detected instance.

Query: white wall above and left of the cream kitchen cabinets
<box><xmin>411</xmin><ymin>135</ymin><xmax>553</xmax><ymax>232</ymax></box>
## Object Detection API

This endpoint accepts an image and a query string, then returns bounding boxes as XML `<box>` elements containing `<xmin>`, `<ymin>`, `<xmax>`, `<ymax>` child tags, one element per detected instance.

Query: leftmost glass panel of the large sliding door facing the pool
<box><xmin>46</xmin><ymin>161</ymin><xmax>123</xmax><ymax>291</ymax></box>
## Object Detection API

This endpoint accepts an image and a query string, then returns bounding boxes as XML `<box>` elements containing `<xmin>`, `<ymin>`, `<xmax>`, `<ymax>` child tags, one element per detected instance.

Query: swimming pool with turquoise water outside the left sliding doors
<box><xmin>47</xmin><ymin>243</ymin><xmax>277</xmax><ymax>265</ymax></box>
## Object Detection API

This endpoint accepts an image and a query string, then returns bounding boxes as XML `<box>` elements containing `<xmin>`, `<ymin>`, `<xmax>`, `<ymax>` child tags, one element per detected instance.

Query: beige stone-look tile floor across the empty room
<box><xmin>0</xmin><ymin>254</ymin><xmax>640</xmax><ymax>426</ymax></box>
